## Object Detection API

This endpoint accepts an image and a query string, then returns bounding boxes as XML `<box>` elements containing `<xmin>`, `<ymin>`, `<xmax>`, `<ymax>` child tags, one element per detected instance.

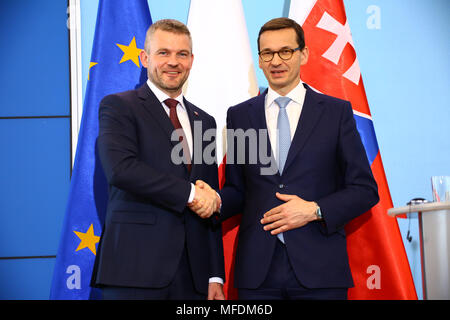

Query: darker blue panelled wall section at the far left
<box><xmin>0</xmin><ymin>0</ymin><xmax>71</xmax><ymax>299</ymax></box>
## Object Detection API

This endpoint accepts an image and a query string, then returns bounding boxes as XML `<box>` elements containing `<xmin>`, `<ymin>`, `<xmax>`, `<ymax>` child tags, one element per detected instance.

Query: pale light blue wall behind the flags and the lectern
<box><xmin>82</xmin><ymin>0</ymin><xmax>450</xmax><ymax>298</ymax></box>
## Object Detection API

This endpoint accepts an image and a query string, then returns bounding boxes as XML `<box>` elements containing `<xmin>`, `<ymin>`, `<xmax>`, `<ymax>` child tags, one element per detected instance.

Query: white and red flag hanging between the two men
<box><xmin>184</xmin><ymin>0</ymin><xmax>258</xmax><ymax>299</ymax></box>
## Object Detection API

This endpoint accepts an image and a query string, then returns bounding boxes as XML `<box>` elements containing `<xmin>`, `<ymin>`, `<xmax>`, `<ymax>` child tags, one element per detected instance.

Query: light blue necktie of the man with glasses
<box><xmin>275</xmin><ymin>97</ymin><xmax>291</xmax><ymax>243</ymax></box>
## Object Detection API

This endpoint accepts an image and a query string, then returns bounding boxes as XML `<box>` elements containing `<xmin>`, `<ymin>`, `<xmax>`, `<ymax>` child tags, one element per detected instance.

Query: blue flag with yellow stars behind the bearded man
<box><xmin>50</xmin><ymin>0</ymin><xmax>152</xmax><ymax>300</ymax></box>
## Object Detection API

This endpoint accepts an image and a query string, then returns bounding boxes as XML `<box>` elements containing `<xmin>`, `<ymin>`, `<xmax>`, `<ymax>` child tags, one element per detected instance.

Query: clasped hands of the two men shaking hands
<box><xmin>188</xmin><ymin>180</ymin><xmax>222</xmax><ymax>219</ymax></box>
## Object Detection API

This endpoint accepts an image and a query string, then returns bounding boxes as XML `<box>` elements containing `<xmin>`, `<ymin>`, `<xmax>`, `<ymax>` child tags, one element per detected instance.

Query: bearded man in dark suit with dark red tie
<box><xmin>93</xmin><ymin>20</ymin><xmax>224</xmax><ymax>300</ymax></box>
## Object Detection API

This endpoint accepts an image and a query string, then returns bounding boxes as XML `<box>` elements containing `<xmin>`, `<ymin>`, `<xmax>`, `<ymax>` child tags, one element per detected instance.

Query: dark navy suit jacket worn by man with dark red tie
<box><xmin>93</xmin><ymin>84</ymin><xmax>225</xmax><ymax>293</ymax></box>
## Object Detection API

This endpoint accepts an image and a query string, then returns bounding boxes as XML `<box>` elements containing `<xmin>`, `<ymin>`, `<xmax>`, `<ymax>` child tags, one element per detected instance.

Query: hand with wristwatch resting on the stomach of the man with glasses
<box><xmin>261</xmin><ymin>192</ymin><xmax>317</xmax><ymax>235</ymax></box>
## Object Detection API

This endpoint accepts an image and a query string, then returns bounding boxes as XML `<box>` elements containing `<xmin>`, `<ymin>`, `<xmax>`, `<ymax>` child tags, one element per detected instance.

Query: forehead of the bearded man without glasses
<box><xmin>150</xmin><ymin>29</ymin><xmax>192</xmax><ymax>51</ymax></box>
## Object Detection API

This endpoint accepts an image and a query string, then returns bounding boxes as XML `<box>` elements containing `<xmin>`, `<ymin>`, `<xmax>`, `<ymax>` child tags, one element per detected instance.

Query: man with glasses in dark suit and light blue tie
<box><xmin>194</xmin><ymin>18</ymin><xmax>379</xmax><ymax>299</ymax></box>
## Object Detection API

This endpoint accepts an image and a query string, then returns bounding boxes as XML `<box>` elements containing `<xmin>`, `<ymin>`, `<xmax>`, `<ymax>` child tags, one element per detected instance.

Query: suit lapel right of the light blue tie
<box><xmin>283</xmin><ymin>85</ymin><xmax>323</xmax><ymax>172</ymax></box>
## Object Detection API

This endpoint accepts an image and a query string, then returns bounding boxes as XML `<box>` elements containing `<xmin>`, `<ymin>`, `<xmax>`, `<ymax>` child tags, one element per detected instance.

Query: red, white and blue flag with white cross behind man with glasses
<box><xmin>289</xmin><ymin>0</ymin><xmax>417</xmax><ymax>300</ymax></box>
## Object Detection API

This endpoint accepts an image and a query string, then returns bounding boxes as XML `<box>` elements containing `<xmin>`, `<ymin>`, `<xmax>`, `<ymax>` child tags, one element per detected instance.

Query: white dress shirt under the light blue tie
<box><xmin>264</xmin><ymin>81</ymin><xmax>306</xmax><ymax>161</ymax></box>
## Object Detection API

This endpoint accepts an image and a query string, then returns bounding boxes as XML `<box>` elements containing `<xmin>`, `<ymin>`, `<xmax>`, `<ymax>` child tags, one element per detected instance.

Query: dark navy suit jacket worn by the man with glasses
<box><xmin>219</xmin><ymin>85</ymin><xmax>378</xmax><ymax>288</ymax></box>
